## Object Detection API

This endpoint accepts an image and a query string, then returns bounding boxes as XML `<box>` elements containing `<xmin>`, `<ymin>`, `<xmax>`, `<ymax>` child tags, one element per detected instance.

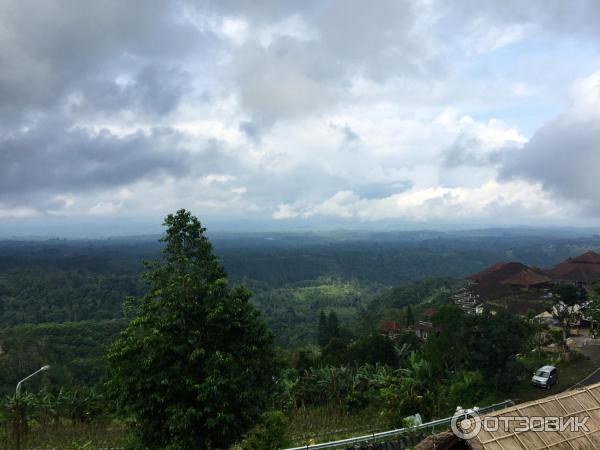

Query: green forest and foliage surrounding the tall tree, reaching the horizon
<box><xmin>0</xmin><ymin>231</ymin><xmax>600</xmax><ymax>448</ymax></box>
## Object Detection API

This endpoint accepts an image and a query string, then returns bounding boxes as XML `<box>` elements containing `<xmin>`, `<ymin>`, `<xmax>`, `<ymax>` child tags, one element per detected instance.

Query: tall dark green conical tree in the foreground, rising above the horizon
<box><xmin>106</xmin><ymin>210</ymin><xmax>275</xmax><ymax>450</ymax></box>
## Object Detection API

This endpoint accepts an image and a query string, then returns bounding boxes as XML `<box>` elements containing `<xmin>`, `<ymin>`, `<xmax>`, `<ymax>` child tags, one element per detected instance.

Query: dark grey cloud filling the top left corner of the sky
<box><xmin>0</xmin><ymin>0</ymin><xmax>204</xmax><ymax>114</ymax></box>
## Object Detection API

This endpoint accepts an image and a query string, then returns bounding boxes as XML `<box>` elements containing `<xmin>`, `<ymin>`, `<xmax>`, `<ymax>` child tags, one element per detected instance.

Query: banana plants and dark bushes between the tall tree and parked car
<box><xmin>278</xmin><ymin>305</ymin><xmax>532</xmax><ymax>432</ymax></box>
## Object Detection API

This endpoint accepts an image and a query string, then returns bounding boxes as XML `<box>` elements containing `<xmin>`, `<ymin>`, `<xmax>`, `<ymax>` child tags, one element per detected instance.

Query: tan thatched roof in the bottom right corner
<box><xmin>415</xmin><ymin>383</ymin><xmax>600</xmax><ymax>450</ymax></box>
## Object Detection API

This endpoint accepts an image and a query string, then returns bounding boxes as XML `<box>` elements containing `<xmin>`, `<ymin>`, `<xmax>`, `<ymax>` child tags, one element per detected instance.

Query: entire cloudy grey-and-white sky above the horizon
<box><xmin>0</xmin><ymin>0</ymin><xmax>600</xmax><ymax>232</ymax></box>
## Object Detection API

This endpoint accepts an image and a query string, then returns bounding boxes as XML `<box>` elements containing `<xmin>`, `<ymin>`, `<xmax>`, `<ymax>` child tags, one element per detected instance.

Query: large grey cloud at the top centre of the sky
<box><xmin>225</xmin><ymin>1</ymin><xmax>431</xmax><ymax>124</ymax></box>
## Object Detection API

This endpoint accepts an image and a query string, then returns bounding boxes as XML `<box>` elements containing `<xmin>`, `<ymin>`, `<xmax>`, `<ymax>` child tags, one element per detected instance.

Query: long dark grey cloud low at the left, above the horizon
<box><xmin>0</xmin><ymin>120</ymin><xmax>190</xmax><ymax>204</ymax></box>
